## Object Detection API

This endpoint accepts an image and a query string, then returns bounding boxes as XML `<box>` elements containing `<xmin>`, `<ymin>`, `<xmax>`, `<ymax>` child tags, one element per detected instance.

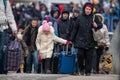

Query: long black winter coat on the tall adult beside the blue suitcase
<box><xmin>70</xmin><ymin>14</ymin><xmax>102</xmax><ymax>49</ymax></box>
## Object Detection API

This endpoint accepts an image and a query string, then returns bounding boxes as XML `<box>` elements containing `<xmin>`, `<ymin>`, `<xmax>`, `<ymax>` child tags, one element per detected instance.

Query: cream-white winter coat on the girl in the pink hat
<box><xmin>36</xmin><ymin>26</ymin><xmax>66</xmax><ymax>59</ymax></box>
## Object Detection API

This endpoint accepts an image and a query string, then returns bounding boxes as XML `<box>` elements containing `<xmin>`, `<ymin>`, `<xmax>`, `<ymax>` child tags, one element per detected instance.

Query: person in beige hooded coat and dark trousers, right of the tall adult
<box><xmin>95</xmin><ymin>13</ymin><xmax>110</xmax><ymax>73</ymax></box>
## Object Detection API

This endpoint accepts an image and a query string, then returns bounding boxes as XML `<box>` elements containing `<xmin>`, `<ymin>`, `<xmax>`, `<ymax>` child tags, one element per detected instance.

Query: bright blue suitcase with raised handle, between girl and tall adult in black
<box><xmin>59</xmin><ymin>45</ymin><xmax>76</xmax><ymax>74</ymax></box>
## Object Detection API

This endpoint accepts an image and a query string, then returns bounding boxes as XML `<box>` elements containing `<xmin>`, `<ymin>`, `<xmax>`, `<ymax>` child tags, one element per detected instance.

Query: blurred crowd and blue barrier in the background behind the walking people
<box><xmin>10</xmin><ymin>0</ymin><xmax>120</xmax><ymax>34</ymax></box>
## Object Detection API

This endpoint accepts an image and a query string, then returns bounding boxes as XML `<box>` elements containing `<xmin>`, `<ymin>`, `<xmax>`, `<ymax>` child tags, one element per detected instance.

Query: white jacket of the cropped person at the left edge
<box><xmin>0</xmin><ymin>0</ymin><xmax>17</xmax><ymax>32</ymax></box>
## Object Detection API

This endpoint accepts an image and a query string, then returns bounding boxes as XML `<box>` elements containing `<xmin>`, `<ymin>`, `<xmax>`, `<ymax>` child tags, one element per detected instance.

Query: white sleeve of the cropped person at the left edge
<box><xmin>6</xmin><ymin>0</ymin><xmax>17</xmax><ymax>32</ymax></box>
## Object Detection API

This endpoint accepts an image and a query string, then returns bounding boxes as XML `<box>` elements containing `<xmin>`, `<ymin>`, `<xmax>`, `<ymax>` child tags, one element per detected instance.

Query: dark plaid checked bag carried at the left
<box><xmin>6</xmin><ymin>40</ymin><xmax>22</xmax><ymax>71</ymax></box>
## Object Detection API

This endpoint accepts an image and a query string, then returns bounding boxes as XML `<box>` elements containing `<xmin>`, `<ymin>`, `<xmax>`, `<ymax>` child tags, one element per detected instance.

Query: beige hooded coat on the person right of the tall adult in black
<box><xmin>95</xmin><ymin>14</ymin><xmax>110</xmax><ymax>47</ymax></box>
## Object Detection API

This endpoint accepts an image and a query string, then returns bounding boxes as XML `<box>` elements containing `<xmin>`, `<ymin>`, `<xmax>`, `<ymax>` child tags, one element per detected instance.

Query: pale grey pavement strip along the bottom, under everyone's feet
<box><xmin>0</xmin><ymin>73</ymin><xmax>120</xmax><ymax>80</ymax></box>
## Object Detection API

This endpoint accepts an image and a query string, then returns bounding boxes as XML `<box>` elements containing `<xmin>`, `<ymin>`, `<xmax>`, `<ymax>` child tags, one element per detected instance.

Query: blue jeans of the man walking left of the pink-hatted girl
<box><xmin>26</xmin><ymin>51</ymin><xmax>38</xmax><ymax>73</ymax></box>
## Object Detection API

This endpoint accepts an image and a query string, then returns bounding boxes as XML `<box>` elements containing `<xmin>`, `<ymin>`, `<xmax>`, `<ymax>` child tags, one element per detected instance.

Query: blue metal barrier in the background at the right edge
<box><xmin>104</xmin><ymin>16</ymin><xmax>119</xmax><ymax>32</ymax></box>
